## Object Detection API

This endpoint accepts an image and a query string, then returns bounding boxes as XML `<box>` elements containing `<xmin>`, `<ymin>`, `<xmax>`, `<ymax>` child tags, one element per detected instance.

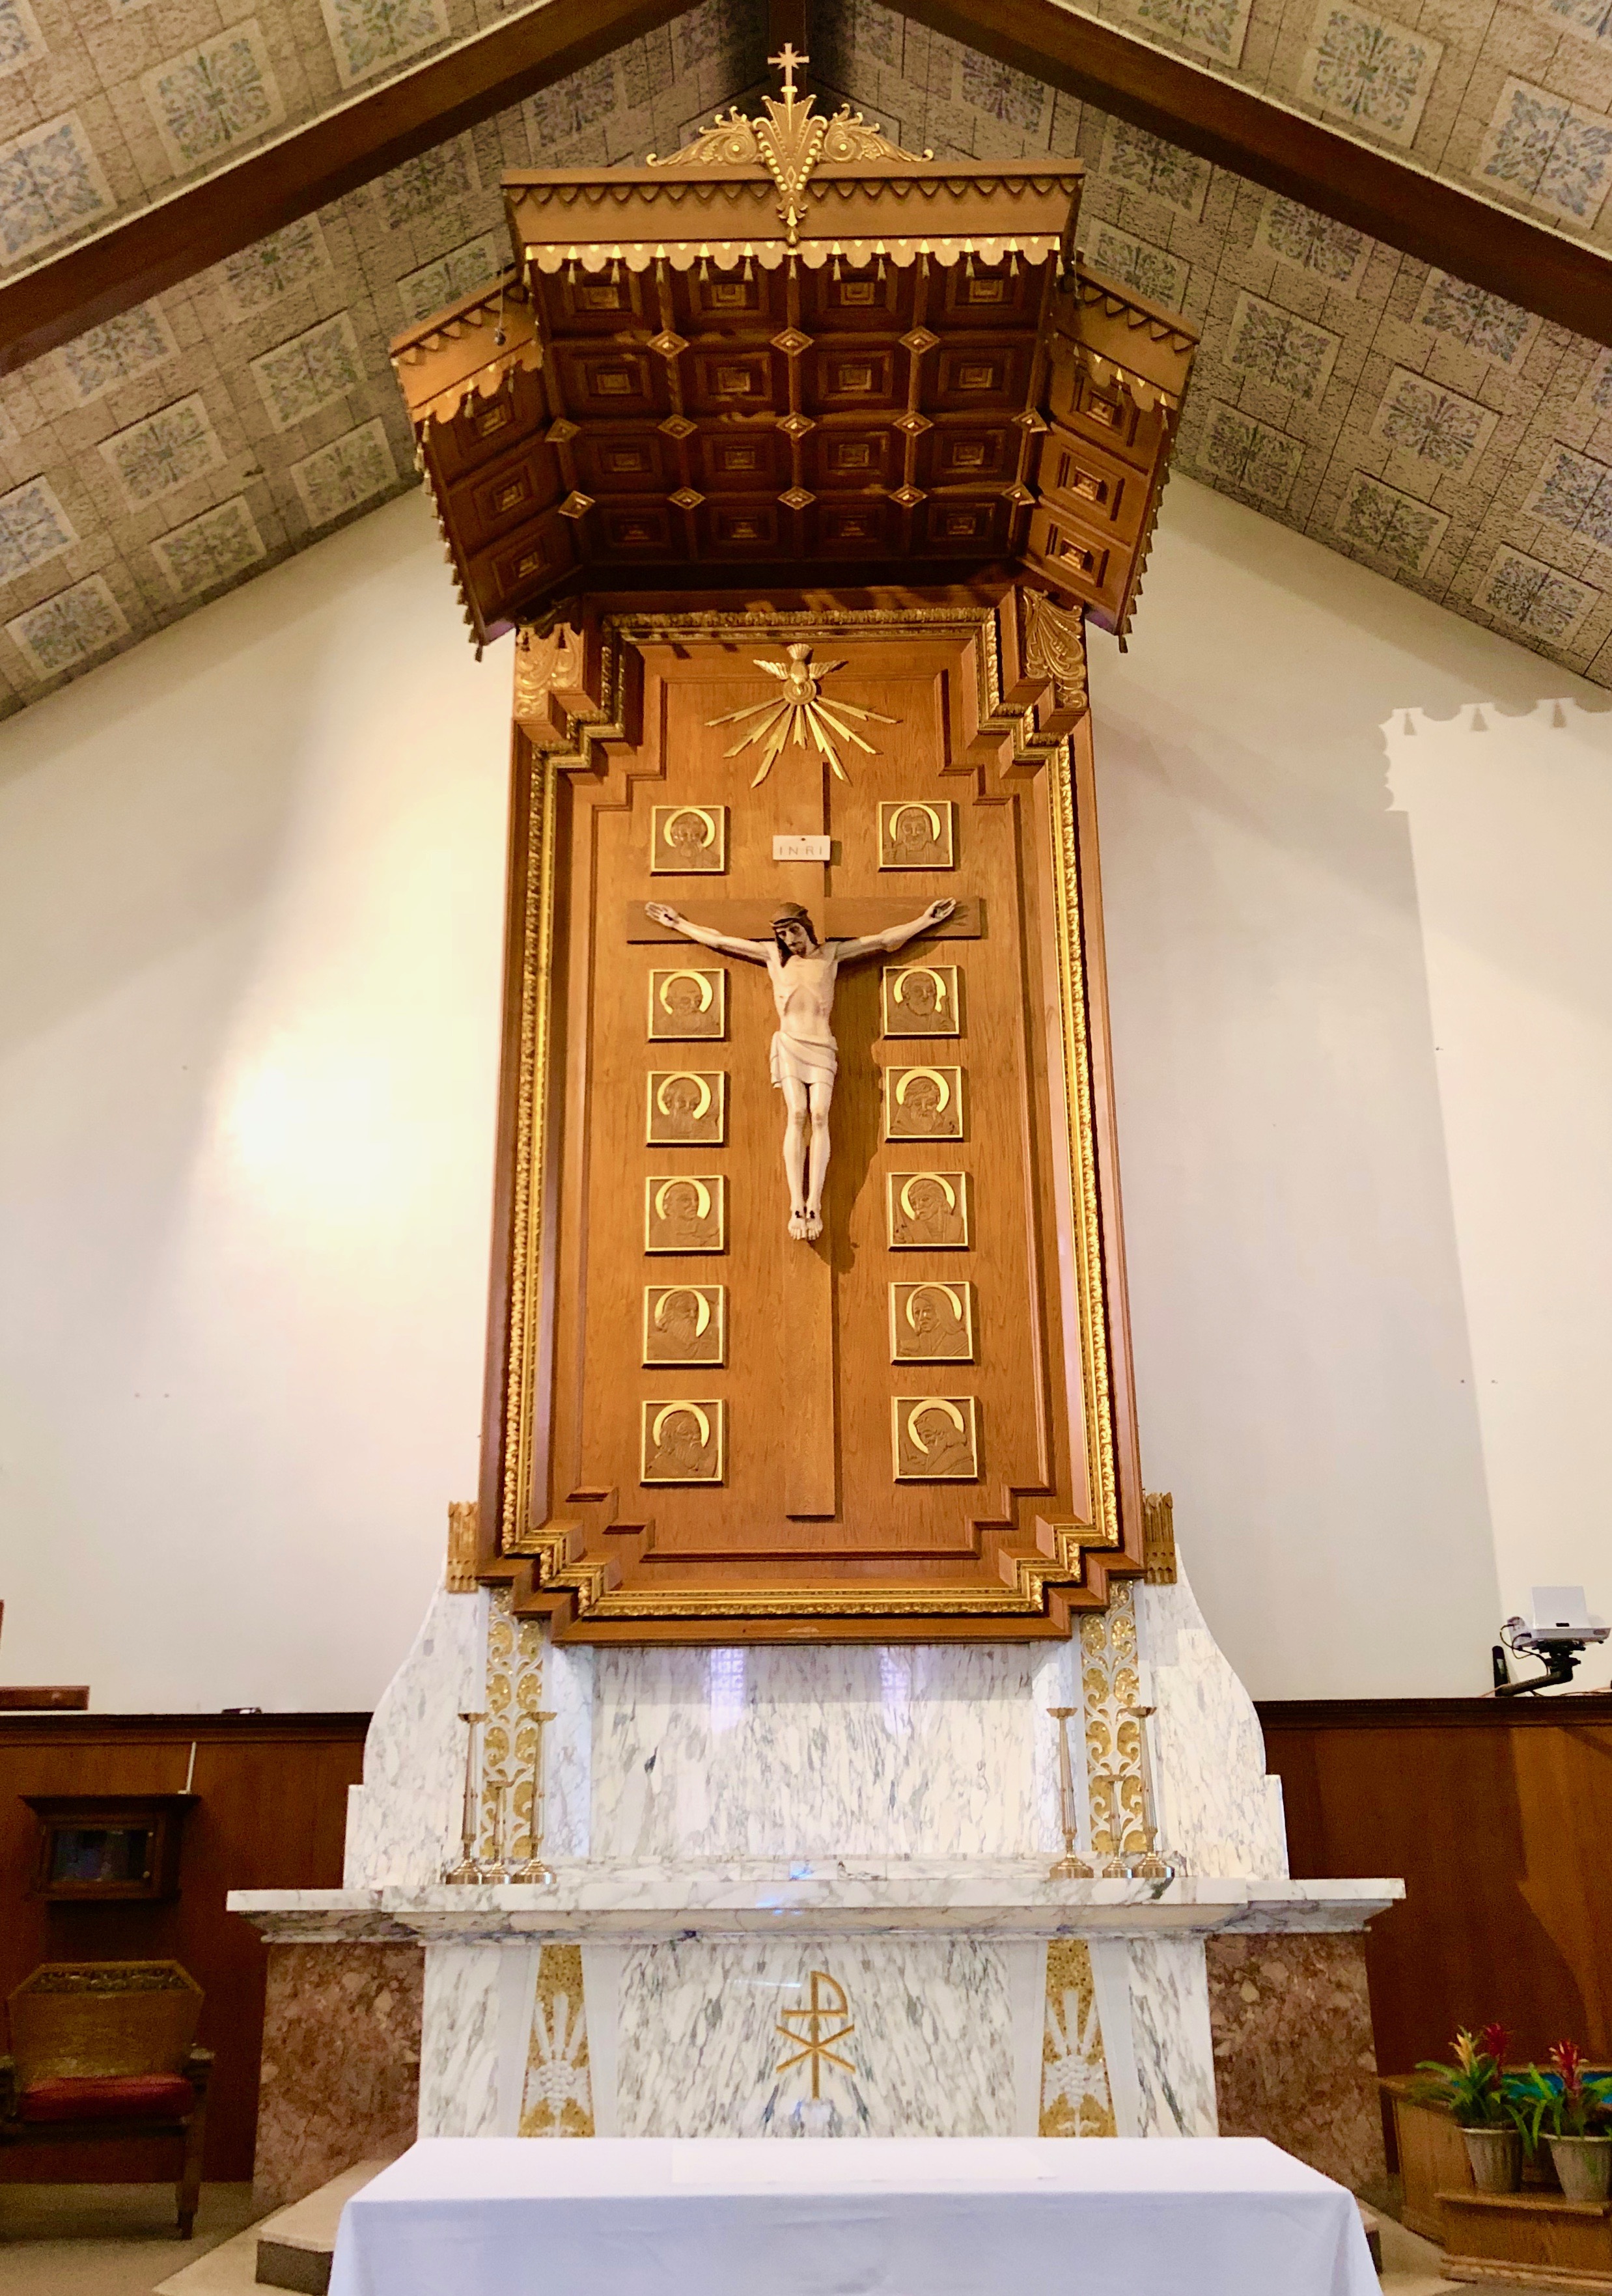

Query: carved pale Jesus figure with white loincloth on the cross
<box><xmin>645</xmin><ymin>900</ymin><xmax>958</xmax><ymax>1242</ymax></box>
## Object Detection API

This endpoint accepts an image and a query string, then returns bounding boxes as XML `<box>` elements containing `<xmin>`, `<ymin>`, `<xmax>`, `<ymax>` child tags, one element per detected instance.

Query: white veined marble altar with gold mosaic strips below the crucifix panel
<box><xmin>232</xmin><ymin>1577</ymin><xmax>1398</xmax><ymax>2138</ymax></box>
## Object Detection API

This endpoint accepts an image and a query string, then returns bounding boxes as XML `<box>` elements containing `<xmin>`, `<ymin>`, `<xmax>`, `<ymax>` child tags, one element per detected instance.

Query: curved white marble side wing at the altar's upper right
<box><xmin>1137</xmin><ymin>1561</ymin><xmax>1288</xmax><ymax>1876</ymax></box>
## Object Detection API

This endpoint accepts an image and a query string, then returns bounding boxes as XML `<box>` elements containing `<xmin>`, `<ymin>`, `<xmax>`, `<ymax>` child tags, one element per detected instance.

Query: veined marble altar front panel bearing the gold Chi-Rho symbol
<box><xmin>615</xmin><ymin>1935</ymin><xmax>1024</xmax><ymax>2138</ymax></box>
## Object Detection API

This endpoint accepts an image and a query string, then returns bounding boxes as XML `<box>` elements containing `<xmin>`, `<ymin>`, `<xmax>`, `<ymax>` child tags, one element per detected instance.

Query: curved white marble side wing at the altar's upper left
<box><xmin>342</xmin><ymin>1586</ymin><xmax>487</xmax><ymax>1890</ymax></box>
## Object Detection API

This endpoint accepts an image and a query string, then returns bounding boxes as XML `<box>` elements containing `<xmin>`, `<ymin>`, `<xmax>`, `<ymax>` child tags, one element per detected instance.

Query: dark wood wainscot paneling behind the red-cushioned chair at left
<box><xmin>0</xmin><ymin>1713</ymin><xmax>370</xmax><ymax>2183</ymax></box>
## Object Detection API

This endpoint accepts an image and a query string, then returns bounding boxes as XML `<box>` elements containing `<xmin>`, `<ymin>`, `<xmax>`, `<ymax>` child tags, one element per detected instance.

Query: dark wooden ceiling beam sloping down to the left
<box><xmin>0</xmin><ymin>0</ymin><xmax>689</xmax><ymax>374</ymax></box>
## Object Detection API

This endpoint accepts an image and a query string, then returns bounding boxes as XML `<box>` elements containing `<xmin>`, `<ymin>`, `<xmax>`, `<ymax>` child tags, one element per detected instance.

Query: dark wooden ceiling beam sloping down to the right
<box><xmin>896</xmin><ymin>0</ymin><xmax>1612</xmax><ymax>344</ymax></box>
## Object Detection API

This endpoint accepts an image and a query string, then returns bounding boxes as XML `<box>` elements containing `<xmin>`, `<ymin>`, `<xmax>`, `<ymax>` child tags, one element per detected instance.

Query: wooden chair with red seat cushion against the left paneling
<box><xmin>0</xmin><ymin>1961</ymin><xmax>214</xmax><ymax>2241</ymax></box>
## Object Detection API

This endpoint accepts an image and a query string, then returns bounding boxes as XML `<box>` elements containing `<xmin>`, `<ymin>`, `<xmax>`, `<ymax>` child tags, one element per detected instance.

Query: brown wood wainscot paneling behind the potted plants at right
<box><xmin>1258</xmin><ymin>1692</ymin><xmax>1612</xmax><ymax>2121</ymax></box>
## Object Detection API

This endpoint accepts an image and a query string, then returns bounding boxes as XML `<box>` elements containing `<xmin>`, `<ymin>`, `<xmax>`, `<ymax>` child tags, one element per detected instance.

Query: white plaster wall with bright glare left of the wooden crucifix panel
<box><xmin>0</xmin><ymin>496</ymin><xmax>510</xmax><ymax>1711</ymax></box>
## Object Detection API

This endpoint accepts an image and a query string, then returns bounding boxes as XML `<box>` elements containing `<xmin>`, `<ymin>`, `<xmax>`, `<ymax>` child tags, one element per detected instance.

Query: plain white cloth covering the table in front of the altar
<box><xmin>331</xmin><ymin>2138</ymin><xmax>1378</xmax><ymax>2296</ymax></box>
